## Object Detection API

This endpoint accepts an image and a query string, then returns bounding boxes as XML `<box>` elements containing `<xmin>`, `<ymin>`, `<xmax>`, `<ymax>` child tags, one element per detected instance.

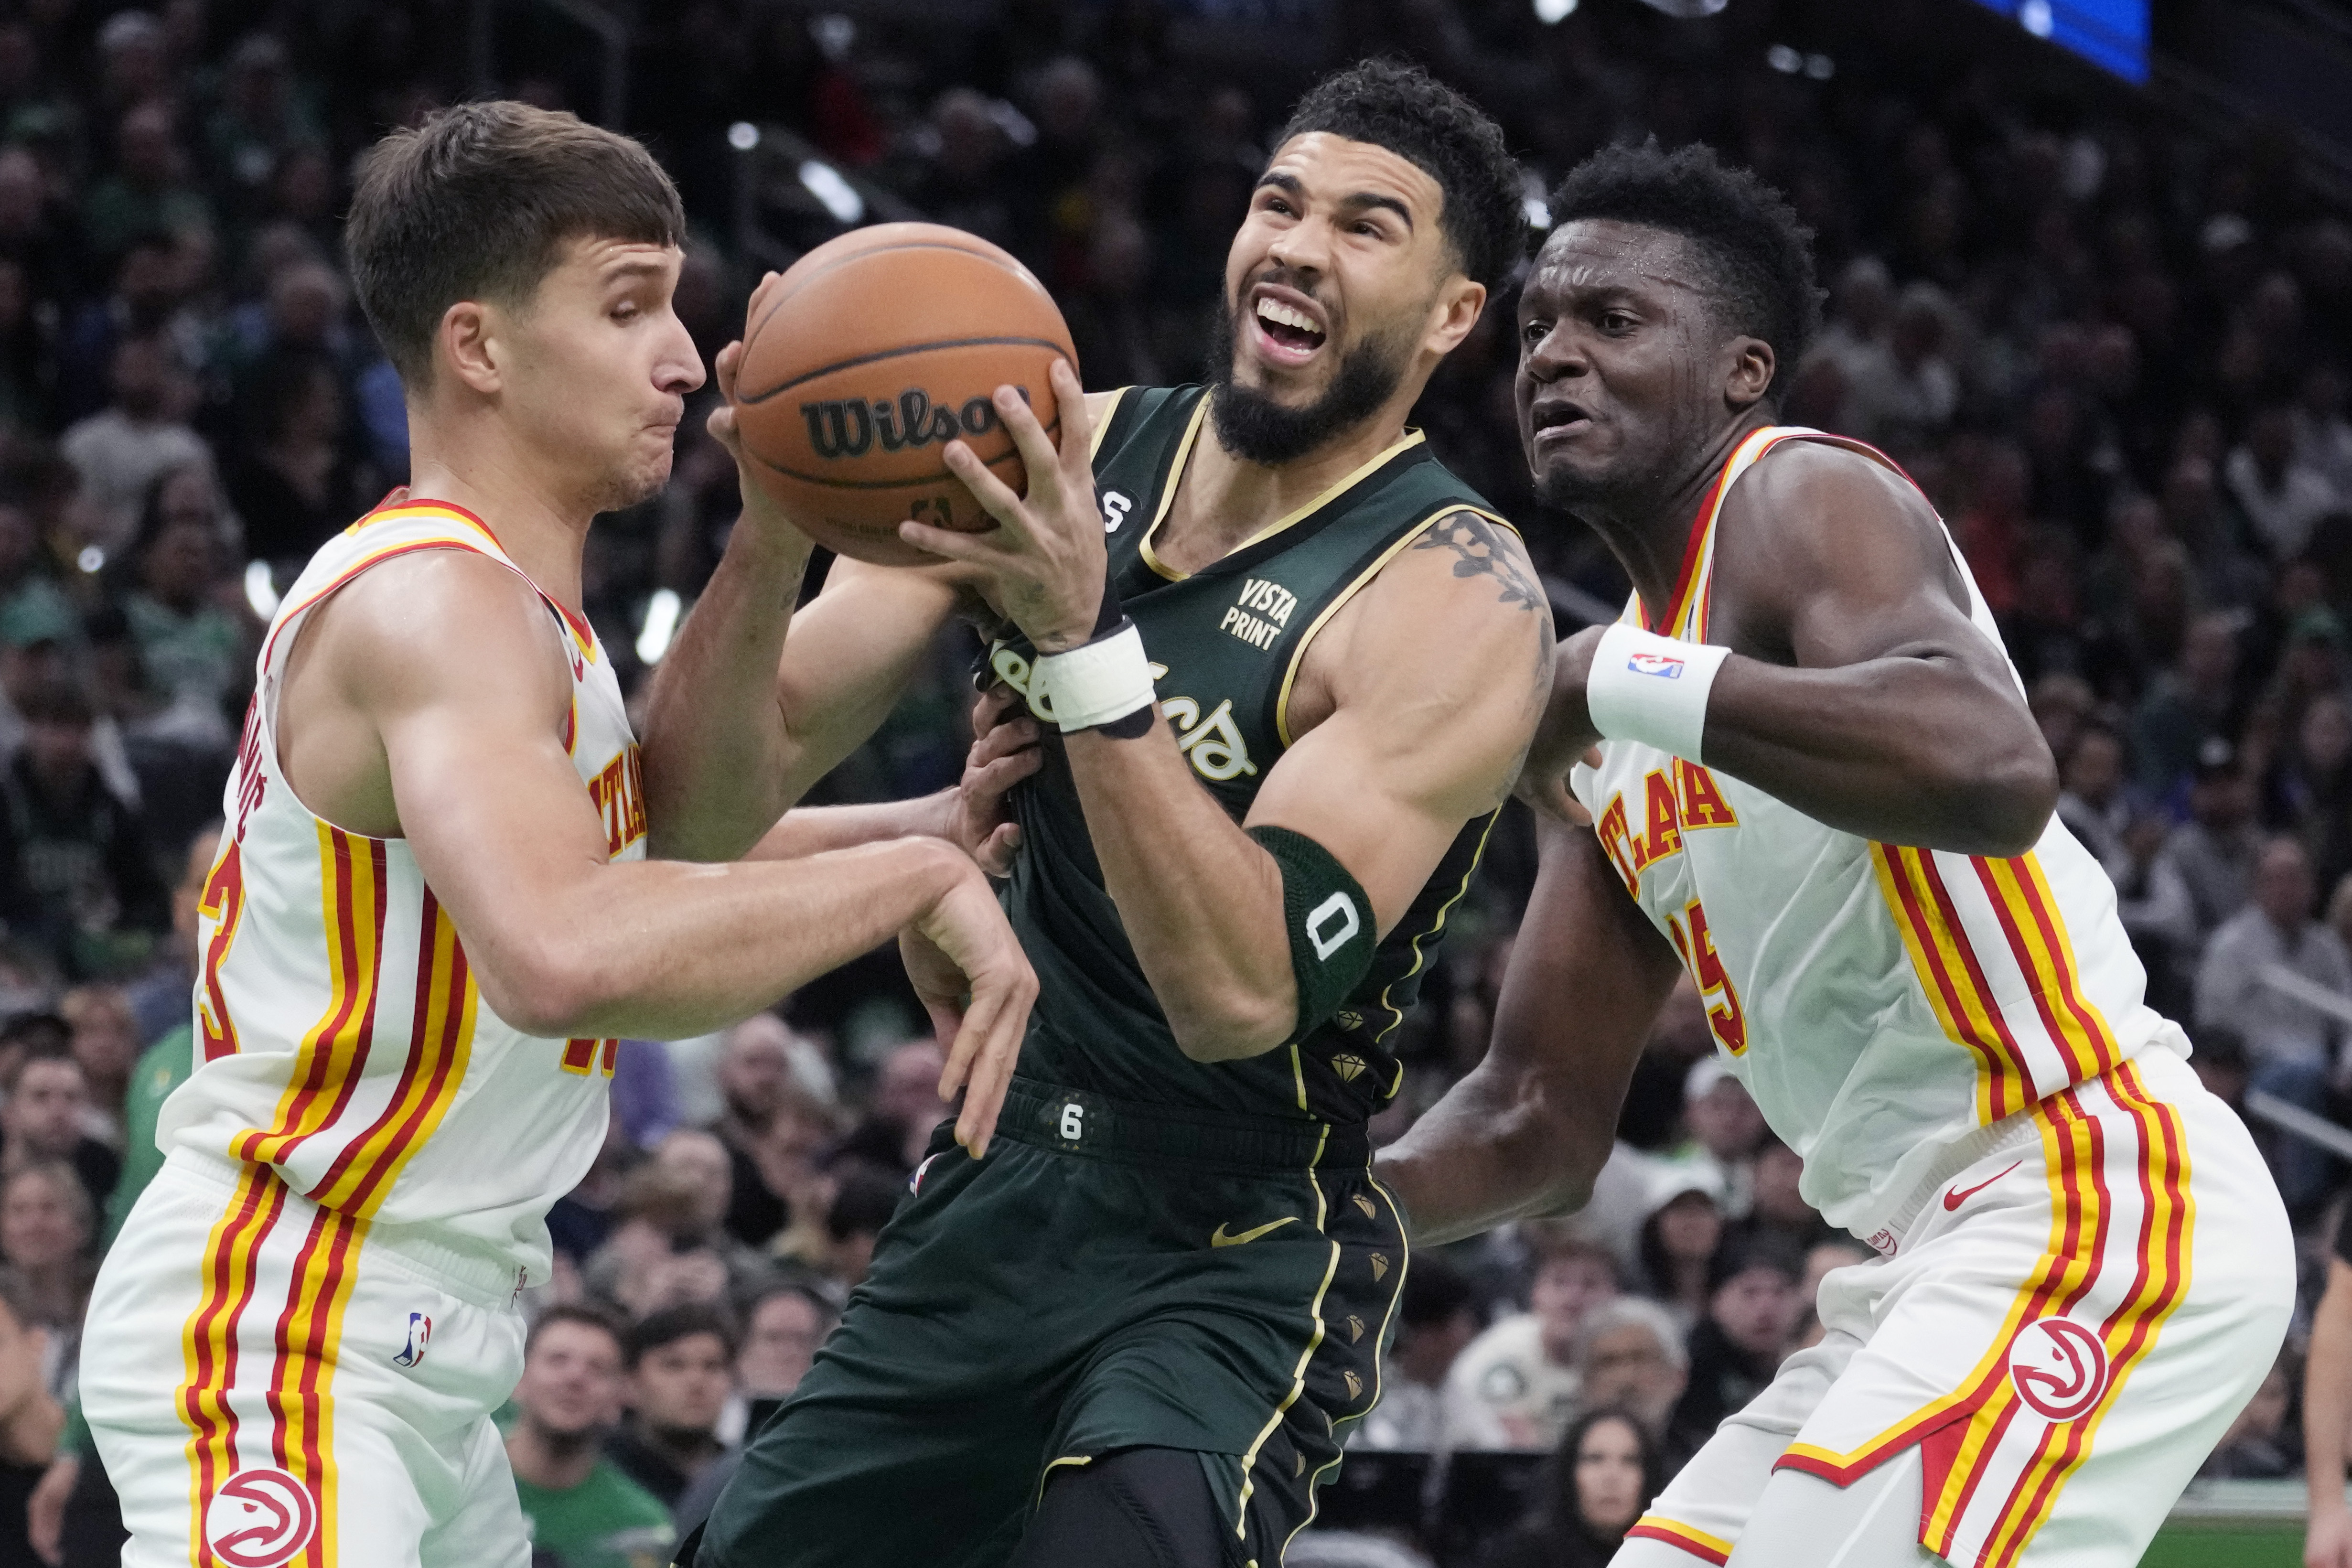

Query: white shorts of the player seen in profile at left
<box><xmin>82</xmin><ymin>1154</ymin><xmax>529</xmax><ymax>1568</ymax></box>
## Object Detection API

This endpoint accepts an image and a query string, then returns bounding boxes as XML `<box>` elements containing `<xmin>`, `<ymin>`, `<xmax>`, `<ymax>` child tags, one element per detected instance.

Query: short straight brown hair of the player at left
<box><xmin>344</xmin><ymin>101</ymin><xmax>687</xmax><ymax>390</ymax></box>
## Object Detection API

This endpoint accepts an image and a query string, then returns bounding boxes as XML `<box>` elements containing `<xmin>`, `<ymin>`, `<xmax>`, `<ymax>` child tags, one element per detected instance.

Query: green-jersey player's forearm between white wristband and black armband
<box><xmin>1068</xmin><ymin>724</ymin><xmax>1298</xmax><ymax>1063</ymax></box>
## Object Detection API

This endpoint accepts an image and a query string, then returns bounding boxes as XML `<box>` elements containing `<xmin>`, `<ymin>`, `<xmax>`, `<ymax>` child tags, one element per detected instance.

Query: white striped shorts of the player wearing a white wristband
<box><xmin>1616</xmin><ymin>1049</ymin><xmax>2296</xmax><ymax>1568</ymax></box>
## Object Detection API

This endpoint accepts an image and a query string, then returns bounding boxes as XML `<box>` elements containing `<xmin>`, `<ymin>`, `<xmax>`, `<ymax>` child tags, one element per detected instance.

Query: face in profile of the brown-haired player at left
<box><xmin>501</xmin><ymin>240</ymin><xmax>703</xmax><ymax>513</ymax></box>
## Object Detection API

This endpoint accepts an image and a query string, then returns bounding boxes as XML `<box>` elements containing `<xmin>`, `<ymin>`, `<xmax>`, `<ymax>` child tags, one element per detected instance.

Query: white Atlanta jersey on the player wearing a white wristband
<box><xmin>1569</xmin><ymin>426</ymin><xmax>2187</xmax><ymax>1239</ymax></box>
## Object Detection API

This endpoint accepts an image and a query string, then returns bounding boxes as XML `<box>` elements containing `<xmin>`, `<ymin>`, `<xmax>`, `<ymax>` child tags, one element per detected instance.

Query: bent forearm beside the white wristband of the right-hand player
<box><xmin>1705</xmin><ymin>656</ymin><xmax>2058</xmax><ymax>856</ymax></box>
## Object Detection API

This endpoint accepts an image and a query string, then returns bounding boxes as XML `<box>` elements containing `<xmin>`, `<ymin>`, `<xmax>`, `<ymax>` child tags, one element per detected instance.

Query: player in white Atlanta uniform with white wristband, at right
<box><xmin>1381</xmin><ymin>146</ymin><xmax>2293</xmax><ymax>1568</ymax></box>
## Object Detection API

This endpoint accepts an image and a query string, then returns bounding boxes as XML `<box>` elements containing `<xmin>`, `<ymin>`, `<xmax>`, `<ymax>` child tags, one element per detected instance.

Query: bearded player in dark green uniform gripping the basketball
<box><xmin>647</xmin><ymin>64</ymin><xmax>1550</xmax><ymax>1568</ymax></box>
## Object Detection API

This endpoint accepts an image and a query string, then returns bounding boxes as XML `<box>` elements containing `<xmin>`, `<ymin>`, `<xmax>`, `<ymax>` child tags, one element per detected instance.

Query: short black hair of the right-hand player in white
<box><xmin>1552</xmin><ymin>136</ymin><xmax>1820</xmax><ymax>383</ymax></box>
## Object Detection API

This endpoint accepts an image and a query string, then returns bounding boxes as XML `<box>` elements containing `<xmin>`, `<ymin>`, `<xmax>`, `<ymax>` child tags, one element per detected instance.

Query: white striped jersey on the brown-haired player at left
<box><xmin>158</xmin><ymin>491</ymin><xmax>644</xmax><ymax>1281</ymax></box>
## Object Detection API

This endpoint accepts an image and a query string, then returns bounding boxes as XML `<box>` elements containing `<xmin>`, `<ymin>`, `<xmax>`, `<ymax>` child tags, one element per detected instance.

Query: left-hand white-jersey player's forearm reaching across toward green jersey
<box><xmin>477</xmin><ymin>839</ymin><xmax>981</xmax><ymax>1039</ymax></box>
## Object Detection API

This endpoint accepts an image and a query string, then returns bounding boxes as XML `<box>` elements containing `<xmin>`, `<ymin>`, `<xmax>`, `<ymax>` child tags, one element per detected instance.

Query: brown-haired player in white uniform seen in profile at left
<box><xmin>82</xmin><ymin>104</ymin><xmax>1035</xmax><ymax>1568</ymax></box>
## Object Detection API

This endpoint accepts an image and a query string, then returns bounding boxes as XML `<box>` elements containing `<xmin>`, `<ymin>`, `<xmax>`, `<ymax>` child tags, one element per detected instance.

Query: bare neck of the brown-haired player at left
<box><xmin>409</xmin><ymin>407</ymin><xmax>595</xmax><ymax>613</ymax></box>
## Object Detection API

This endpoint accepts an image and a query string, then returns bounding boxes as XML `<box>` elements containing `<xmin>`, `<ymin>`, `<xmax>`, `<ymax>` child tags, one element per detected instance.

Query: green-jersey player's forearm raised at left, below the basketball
<box><xmin>644</xmin><ymin>522</ymin><xmax>809</xmax><ymax>860</ymax></box>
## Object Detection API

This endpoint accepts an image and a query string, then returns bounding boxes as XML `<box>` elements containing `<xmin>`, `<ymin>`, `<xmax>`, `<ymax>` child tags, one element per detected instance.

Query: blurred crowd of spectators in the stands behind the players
<box><xmin>0</xmin><ymin>0</ymin><xmax>2352</xmax><ymax>1568</ymax></box>
